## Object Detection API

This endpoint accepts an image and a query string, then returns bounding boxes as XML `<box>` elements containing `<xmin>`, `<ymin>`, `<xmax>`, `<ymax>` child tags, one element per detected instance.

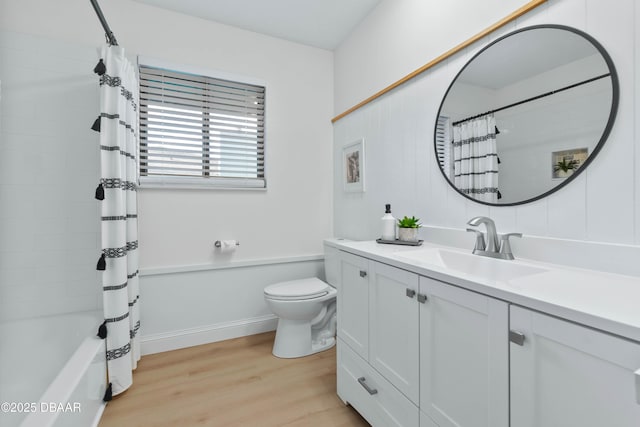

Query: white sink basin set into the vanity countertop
<box><xmin>396</xmin><ymin>248</ymin><xmax>548</xmax><ymax>281</ymax></box>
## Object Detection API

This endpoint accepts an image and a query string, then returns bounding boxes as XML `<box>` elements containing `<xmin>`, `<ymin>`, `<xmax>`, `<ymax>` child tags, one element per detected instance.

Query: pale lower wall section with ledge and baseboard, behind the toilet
<box><xmin>140</xmin><ymin>257</ymin><xmax>324</xmax><ymax>354</ymax></box>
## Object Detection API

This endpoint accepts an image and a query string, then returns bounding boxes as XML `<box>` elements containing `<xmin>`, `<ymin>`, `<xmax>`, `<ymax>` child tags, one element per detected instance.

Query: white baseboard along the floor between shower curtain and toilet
<box><xmin>140</xmin><ymin>315</ymin><xmax>278</xmax><ymax>356</ymax></box>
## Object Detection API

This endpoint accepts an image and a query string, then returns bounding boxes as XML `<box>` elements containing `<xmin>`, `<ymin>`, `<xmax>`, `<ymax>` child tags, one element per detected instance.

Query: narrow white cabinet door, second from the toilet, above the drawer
<box><xmin>369</xmin><ymin>262</ymin><xmax>420</xmax><ymax>405</ymax></box>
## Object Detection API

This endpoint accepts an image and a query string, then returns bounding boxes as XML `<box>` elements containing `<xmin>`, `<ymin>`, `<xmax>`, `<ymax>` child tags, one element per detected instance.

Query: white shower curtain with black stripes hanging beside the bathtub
<box><xmin>100</xmin><ymin>46</ymin><xmax>140</xmax><ymax>395</ymax></box>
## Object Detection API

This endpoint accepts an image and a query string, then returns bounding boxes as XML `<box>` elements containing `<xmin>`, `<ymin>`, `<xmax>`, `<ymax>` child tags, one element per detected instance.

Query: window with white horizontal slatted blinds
<box><xmin>139</xmin><ymin>64</ymin><xmax>266</xmax><ymax>188</ymax></box>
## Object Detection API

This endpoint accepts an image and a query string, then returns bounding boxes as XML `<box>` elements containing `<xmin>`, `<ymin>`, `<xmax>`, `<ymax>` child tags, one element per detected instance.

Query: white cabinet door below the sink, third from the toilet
<box><xmin>419</xmin><ymin>277</ymin><xmax>510</xmax><ymax>427</ymax></box>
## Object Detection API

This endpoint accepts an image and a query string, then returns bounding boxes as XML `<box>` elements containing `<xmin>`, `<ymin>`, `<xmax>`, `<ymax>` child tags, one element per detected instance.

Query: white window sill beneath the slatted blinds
<box><xmin>138</xmin><ymin>176</ymin><xmax>267</xmax><ymax>191</ymax></box>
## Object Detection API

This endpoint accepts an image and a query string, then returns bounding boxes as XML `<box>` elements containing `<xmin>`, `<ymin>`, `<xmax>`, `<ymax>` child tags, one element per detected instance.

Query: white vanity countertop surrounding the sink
<box><xmin>325</xmin><ymin>239</ymin><xmax>640</xmax><ymax>342</ymax></box>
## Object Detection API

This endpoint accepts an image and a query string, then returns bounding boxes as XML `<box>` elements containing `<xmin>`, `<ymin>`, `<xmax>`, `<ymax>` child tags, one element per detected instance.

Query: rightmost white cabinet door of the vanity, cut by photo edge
<box><xmin>510</xmin><ymin>306</ymin><xmax>640</xmax><ymax>427</ymax></box>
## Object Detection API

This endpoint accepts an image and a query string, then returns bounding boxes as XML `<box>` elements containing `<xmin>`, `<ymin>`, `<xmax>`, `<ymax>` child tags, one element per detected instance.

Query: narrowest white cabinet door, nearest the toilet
<box><xmin>337</xmin><ymin>252</ymin><xmax>369</xmax><ymax>360</ymax></box>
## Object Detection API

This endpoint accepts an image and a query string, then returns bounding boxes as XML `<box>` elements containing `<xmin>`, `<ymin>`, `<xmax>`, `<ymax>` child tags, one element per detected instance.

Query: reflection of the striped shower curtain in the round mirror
<box><xmin>453</xmin><ymin>114</ymin><xmax>498</xmax><ymax>203</ymax></box>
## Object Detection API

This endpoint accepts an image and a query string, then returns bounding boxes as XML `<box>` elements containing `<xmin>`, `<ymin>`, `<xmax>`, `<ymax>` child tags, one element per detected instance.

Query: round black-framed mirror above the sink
<box><xmin>435</xmin><ymin>25</ymin><xmax>619</xmax><ymax>206</ymax></box>
